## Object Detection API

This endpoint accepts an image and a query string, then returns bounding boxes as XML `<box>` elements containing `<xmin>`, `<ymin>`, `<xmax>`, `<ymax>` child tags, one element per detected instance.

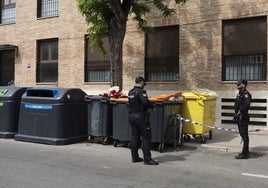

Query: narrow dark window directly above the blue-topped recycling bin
<box><xmin>36</xmin><ymin>39</ymin><xmax>58</xmax><ymax>83</ymax></box>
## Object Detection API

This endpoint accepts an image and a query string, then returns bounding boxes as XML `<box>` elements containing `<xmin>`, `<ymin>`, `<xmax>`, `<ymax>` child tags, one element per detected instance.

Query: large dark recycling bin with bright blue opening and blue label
<box><xmin>14</xmin><ymin>88</ymin><xmax>88</xmax><ymax>145</ymax></box>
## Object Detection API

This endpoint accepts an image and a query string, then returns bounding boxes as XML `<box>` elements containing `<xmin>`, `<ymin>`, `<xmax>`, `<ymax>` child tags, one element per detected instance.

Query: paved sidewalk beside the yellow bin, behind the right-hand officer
<box><xmin>184</xmin><ymin>130</ymin><xmax>268</xmax><ymax>155</ymax></box>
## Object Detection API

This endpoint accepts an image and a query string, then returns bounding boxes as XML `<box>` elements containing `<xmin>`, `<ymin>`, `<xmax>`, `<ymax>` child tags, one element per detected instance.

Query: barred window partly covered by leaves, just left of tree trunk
<box><xmin>85</xmin><ymin>37</ymin><xmax>111</xmax><ymax>82</ymax></box>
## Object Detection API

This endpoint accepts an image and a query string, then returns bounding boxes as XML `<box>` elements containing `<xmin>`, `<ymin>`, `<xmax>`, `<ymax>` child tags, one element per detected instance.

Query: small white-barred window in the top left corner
<box><xmin>0</xmin><ymin>0</ymin><xmax>16</xmax><ymax>24</ymax></box>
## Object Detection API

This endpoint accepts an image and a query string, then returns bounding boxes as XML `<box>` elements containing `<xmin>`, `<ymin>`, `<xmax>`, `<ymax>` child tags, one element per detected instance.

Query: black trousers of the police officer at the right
<box><xmin>237</xmin><ymin>115</ymin><xmax>249</xmax><ymax>154</ymax></box>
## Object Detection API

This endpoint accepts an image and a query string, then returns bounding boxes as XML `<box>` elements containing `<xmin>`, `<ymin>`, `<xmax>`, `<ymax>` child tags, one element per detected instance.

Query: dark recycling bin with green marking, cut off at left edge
<box><xmin>0</xmin><ymin>86</ymin><xmax>27</xmax><ymax>138</ymax></box>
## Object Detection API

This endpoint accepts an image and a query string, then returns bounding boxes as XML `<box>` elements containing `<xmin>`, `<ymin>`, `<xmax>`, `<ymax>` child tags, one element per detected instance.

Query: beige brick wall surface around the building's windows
<box><xmin>0</xmin><ymin>0</ymin><xmax>268</xmax><ymax>92</ymax></box>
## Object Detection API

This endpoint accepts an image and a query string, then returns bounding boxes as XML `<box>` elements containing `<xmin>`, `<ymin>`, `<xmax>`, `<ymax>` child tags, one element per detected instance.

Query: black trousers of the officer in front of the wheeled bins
<box><xmin>129</xmin><ymin>113</ymin><xmax>152</xmax><ymax>162</ymax></box>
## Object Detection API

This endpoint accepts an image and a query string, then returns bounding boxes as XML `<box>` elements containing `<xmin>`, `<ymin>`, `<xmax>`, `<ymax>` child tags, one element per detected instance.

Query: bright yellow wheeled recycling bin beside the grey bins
<box><xmin>181</xmin><ymin>91</ymin><xmax>217</xmax><ymax>143</ymax></box>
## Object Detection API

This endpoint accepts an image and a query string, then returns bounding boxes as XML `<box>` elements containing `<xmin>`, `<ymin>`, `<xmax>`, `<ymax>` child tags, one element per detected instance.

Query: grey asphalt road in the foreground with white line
<box><xmin>0</xmin><ymin>139</ymin><xmax>268</xmax><ymax>188</ymax></box>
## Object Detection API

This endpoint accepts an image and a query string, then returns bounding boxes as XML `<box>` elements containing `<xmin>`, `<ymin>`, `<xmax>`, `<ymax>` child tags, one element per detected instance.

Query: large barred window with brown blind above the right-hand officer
<box><xmin>222</xmin><ymin>16</ymin><xmax>267</xmax><ymax>81</ymax></box>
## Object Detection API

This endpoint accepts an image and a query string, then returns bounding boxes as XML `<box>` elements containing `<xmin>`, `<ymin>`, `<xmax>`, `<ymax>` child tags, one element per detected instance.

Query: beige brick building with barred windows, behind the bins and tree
<box><xmin>0</xmin><ymin>0</ymin><xmax>268</xmax><ymax>128</ymax></box>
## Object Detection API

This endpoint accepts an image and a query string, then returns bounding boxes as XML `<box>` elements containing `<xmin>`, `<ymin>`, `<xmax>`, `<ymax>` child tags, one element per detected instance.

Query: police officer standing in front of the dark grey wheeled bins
<box><xmin>128</xmin><ymin>76</ymin><xmax>158</xmax><ymax>165</ymax></box>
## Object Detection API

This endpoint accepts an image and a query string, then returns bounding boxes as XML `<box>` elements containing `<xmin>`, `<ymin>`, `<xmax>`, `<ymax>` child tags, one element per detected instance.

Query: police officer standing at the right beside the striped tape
<box><xmin>234</xmin><ymin>79</ymin><xmax>251</xmax><ymax>159</ymax></box>
